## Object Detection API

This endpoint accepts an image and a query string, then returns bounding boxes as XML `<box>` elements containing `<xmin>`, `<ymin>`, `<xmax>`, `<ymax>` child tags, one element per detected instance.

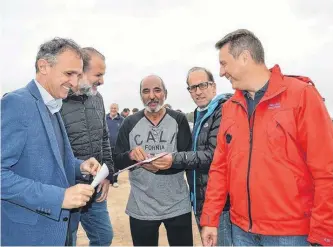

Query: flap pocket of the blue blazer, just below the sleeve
<box><xmin>1</xmin><ymin>202</ymin><xmax>38</xmax><ymax>225</ymax></box>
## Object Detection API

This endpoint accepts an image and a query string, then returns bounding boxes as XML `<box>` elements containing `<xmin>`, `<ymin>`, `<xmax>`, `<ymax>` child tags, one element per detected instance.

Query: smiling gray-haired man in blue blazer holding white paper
<box><xmin>1</xmin><ymin>38</ymin><xmax>100</xmax><ymax>246</ymax></box>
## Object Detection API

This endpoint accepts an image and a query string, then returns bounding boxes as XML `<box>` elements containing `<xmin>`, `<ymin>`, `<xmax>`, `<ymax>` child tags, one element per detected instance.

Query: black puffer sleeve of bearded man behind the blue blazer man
<box><xmin>101</xmin><ymin>98</ymin><xmax>114</xmax><ymax>182</ymax></box>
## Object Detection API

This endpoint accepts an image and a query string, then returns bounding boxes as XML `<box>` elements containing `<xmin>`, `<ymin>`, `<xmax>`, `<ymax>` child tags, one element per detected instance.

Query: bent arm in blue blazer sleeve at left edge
<box><xmin>1</xmin><ymin>94</ymin><xmax>65</xmax><ymax>220</ymax></box>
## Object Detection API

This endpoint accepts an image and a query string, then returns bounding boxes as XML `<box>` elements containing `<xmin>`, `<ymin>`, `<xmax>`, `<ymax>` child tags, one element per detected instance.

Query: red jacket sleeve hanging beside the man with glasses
<box><xmin>200</xmin><ymin>107</ymin><xmax>228</xmax><ymax>227</ymax></box>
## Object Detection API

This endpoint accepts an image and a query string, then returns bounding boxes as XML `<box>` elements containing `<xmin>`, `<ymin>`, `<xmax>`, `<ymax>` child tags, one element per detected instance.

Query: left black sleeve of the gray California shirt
<box><xmin>113</xmin><ymin>117</ymin><xmax>135</xmax><ymax>169</ymax></box>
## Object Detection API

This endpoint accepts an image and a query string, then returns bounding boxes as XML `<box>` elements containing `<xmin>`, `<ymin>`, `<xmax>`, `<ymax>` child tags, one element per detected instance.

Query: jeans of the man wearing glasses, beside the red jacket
<box><xmin>195</xmin><ymin>211</ymin><xmax>232</xmax><ymax>246</ymax></box>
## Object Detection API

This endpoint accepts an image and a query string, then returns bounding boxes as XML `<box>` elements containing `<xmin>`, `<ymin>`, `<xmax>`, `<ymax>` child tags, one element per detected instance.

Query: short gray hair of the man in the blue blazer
<box><xmin>35</xmin><ymin>37</ymin><xmax>82</xmax><ymax>73</ymax></box>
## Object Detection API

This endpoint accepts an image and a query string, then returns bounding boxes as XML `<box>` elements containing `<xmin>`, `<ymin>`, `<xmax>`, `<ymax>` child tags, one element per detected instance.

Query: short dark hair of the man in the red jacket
<box><xmin>215</xmin><ymin>29</ymin><xmax>265</xmax><ymax>64</ymax></box>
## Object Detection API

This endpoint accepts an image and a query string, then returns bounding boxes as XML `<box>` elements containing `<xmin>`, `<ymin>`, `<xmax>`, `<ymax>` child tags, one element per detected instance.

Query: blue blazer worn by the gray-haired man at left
<box><xmin>1</xmin><ymin>81</ymin><xmax>82</xmax><ymax>246</ymax></box>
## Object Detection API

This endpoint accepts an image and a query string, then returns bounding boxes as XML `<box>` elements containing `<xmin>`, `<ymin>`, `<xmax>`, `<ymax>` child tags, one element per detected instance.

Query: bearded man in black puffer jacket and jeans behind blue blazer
<box><xmin>61</xmin><ymin>48</ymin><xmax>113</xmax><ymax>246</ymax></box>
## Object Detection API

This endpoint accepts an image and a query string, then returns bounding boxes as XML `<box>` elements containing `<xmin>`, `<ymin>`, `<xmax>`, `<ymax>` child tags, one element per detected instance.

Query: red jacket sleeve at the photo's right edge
<box><xmin>297</xmin><ymin>85</ymin><xmax>333</xmax><ymax>245</ymax></box>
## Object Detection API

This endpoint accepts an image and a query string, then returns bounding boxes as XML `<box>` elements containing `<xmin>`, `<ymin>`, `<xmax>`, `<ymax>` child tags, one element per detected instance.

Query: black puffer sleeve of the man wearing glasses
<box><xmin>172</xmin><ymin>107</ymin><xmax>222</xmax><ymax>172</ymax></box>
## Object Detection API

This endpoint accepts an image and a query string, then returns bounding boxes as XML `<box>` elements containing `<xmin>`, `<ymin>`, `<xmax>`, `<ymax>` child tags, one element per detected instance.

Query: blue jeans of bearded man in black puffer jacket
<box><xmin>73</xmin><ymin>193</ymin><xmax>113</xmax><ymax>246</ymax></box>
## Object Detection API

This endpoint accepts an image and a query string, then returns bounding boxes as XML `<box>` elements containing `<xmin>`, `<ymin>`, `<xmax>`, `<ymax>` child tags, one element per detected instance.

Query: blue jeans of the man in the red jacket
<box><xmin>232</xmin><ymin>224</ymin><xmax>310</xmax><ymax>246</ymax></box>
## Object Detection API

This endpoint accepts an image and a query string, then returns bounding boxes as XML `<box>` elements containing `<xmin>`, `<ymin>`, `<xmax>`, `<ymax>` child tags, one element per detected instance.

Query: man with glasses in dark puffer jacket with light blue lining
<box><xmin>153</xmin><ymin>67</ymin><xmax>232</xmax><ymax>246</ymax></box>
